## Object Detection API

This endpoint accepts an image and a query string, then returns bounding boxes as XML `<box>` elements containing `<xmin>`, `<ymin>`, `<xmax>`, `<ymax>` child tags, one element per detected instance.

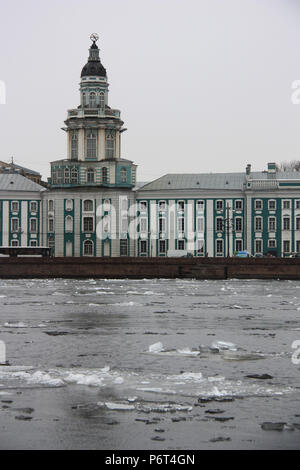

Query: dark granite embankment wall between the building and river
<box><xmin>0</xmin><ymin>257</ymin><xmax>300</xmax><ymax>280</ymax></box>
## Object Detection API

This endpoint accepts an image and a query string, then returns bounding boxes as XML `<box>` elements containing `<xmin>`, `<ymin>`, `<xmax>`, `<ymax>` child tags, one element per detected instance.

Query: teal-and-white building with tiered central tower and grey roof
<box><xmin>0</xmin><ymin>35</ymin><xmax>300</xmax><ymax>257</ymax></box>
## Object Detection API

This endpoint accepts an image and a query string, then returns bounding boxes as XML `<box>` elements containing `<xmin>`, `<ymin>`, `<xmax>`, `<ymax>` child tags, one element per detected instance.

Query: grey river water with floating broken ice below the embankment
<box><xmin>0</xmin><ymin>279</ymin><xmax>300</xmax><ymax>450</ymax></box>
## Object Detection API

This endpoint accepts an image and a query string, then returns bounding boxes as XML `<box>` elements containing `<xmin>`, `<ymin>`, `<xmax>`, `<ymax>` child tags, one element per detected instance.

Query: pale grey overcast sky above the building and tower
<box><xmin>0</xmin><ymin>0</ymin><xmax>300</xmax><ymax>181</ymax></box>
